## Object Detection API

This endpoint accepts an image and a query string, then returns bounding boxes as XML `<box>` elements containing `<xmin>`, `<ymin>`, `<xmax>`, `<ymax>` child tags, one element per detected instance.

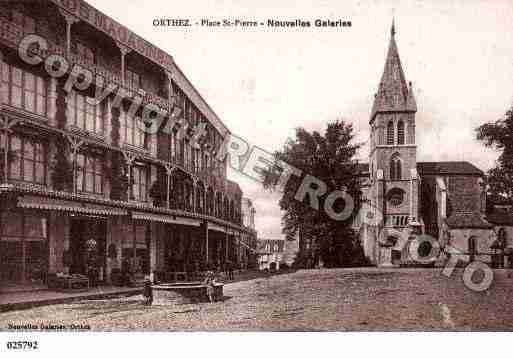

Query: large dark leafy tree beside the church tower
<box><xmin>263</xmin><ymin>120</ymin><xmax>363</xmax><ymax>267</ymax></box>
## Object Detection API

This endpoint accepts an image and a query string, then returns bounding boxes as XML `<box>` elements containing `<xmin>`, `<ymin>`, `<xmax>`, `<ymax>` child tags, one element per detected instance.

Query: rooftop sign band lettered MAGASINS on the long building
<box><xmin>51</xmin><ymin>0</ymin><xmax>173</xmax><ymax>70</ymax></box>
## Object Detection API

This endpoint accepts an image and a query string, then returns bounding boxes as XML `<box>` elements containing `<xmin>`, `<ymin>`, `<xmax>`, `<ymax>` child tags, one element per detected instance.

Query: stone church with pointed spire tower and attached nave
<box><xmin>355</xmin><ymin>24</ymin><xmax>513</xmax><ymax>267</ymax></box>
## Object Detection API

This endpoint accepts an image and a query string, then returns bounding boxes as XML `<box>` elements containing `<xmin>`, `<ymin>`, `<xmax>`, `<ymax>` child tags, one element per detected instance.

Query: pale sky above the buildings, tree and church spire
<box><xmin>88</xmin><ymin>0</ymin><xmax>513</xmax><ymax>239</ymax></box>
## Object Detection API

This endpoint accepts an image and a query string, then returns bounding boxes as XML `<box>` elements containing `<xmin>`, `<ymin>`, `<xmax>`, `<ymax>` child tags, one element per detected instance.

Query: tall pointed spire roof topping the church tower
<box><xmin>370</xmin><ymin>23</ymin><xmax>417</xmax><ymax>121</ymax></box>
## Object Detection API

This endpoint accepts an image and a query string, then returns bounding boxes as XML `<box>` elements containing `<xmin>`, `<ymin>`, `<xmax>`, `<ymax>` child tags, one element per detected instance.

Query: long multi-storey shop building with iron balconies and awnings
<box><xmin>0</xmin><ymin>0</ymin><xmax>256</xmax><ymax>290</ymax></box>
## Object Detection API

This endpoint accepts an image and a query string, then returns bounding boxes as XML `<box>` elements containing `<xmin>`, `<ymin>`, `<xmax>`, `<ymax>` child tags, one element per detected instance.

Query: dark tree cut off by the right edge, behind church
<box><xmin>476</xmin><ymin>108</ymin><xmax>513</xmax><ymax>207</ymax></box>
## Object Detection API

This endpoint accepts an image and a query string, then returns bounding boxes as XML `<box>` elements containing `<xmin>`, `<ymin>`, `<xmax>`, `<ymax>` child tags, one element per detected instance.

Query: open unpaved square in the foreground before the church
<box><xmin>0</xmin><ymin>268</ymin><xmax>513</xmax><ymax>331</ymax></box>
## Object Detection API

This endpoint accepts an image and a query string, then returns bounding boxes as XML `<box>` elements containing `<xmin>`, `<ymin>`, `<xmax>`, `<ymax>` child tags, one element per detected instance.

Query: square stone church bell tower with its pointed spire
<box><xmin>369</xmin><ymin>22</ymin><xmax>419</xmax><ymax>265</ymax></box>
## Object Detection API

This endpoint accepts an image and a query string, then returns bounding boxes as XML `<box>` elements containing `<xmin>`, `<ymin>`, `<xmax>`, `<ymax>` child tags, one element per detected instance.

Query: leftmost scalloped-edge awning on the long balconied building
<box><xmin>18</xmin><ymin>196</ymin><xmax>128</xmax><ymax>216</ymax></box>
